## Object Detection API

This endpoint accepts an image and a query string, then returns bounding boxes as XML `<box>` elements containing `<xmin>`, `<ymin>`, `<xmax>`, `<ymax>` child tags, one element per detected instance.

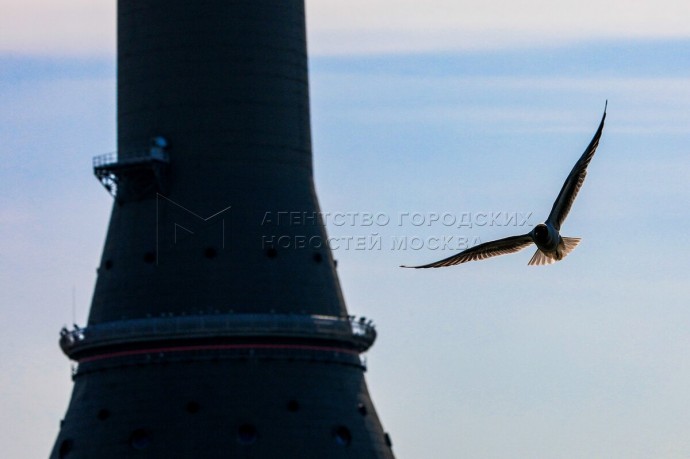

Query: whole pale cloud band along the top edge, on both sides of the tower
<box><xmin>0</xmin><ymin>0</ymin><xmax>690</xmax><ymax>55</ymax></box>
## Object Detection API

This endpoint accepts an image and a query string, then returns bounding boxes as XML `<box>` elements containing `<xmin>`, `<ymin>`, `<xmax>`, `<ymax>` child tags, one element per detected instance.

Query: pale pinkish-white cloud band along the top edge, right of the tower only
<box><xmin>307</xmin><ymin>0</ymin><xmax>690</xmax><ymax>54</ymax></box>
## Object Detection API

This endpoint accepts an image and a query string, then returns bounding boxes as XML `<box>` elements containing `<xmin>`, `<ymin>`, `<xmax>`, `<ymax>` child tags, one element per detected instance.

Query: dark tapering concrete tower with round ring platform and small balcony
<box><xmin>51</xmin><ymin>0</ymin><xmax>393</xmax><ymax>459</ymax></box>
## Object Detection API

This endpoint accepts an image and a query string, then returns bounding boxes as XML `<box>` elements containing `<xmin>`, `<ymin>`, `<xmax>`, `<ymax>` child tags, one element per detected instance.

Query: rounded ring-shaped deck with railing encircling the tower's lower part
<box><xmin>60</xmin><ymin>314</ymin><xmax>376</xmax><ymax>372</ymax></box>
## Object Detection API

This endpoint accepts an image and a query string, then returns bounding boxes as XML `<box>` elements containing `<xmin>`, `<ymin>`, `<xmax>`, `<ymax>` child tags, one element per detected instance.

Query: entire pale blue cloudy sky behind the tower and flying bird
<box><xmin>0</xmin><ymin>0</ymin><xmax>690</xmax><ymax>459</ymax></box>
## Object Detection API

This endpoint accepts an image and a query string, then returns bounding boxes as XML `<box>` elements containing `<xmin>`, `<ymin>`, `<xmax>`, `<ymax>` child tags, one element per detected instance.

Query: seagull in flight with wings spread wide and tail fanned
<box><xmin>401</xmin><ymin>101</ymin><xmax>608</xmax><ymax>268</ymax></box>
